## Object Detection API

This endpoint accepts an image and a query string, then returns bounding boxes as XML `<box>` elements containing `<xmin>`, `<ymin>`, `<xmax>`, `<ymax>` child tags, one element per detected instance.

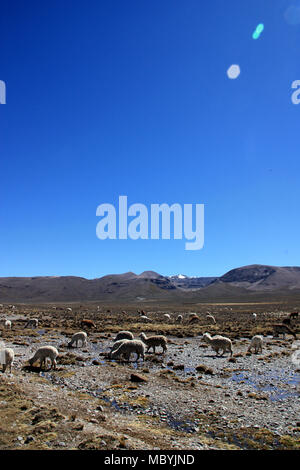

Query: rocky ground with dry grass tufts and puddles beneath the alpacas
<box><xmin>0</xmin><ymin>302</ymin><xmax>300</xmax><ymax>450</ymax></box>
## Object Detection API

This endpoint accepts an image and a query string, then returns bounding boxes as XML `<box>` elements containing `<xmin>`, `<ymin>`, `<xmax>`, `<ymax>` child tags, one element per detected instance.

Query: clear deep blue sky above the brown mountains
<box><xmin>0</xmin><ymin>0</ymin><xmax>300</xmax><ymax>278</ymax></box>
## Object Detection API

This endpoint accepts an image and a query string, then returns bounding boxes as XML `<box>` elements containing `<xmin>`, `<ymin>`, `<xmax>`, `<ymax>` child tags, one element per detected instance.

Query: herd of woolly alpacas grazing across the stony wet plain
<box><xmin>0</xmin><ymin>311</ymin><xmax>298</xmax><ymax>373</ymax></box>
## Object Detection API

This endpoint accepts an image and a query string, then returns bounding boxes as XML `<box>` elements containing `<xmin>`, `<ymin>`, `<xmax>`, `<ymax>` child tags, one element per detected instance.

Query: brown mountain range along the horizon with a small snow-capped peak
<box><xmin>0</xmin><ymin>264</ymin><xmax>300</xmax><ymax>303</ymax></box>
